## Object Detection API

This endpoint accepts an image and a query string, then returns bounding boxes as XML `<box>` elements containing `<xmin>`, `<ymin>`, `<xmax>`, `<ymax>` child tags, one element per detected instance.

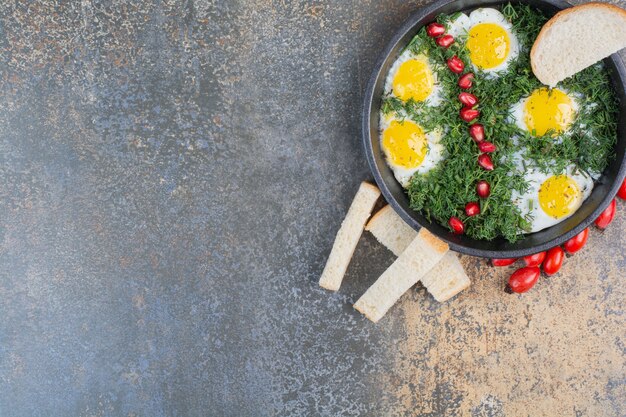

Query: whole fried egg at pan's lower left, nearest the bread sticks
<box><xmin>381</xmin><ymin>115</ymin><xmax>444</xmax><ymax>188</ymax></box>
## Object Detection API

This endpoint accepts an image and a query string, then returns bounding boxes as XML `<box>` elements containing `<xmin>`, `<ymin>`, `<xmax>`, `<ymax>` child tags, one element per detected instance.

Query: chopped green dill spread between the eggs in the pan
<box><xmin>381</xmin><ymin>4</ymin><xmax>618</xmax><ymax>242</ymax></box>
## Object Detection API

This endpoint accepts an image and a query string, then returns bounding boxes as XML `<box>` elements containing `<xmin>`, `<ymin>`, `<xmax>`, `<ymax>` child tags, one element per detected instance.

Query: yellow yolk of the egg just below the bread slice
<box><xmin>524</xmin><ymin>88</ymin><xmax>574</xmax><ymax>136</ymax></box>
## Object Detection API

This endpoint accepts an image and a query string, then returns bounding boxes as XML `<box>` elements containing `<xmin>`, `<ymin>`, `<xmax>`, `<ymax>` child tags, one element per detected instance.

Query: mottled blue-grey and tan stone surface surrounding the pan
<box><xmin>0</xmin><ymin>0</ymin><xmax>626</xmax><ymax>417</ymax></box>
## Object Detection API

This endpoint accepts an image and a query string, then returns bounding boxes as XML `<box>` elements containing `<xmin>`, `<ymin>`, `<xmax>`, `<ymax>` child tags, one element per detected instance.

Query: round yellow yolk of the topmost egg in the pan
<box><xmin>467</xmin><ymin>23</ymin><xmax>511</xmax><ymax>69</ymax></box>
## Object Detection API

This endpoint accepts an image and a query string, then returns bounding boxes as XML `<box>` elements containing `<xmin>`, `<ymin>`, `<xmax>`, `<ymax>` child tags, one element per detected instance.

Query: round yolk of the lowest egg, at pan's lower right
<box><xmin>539</xmin><ymin>175</ymin><xmax>581</xmax><ymax>219</ymax></box>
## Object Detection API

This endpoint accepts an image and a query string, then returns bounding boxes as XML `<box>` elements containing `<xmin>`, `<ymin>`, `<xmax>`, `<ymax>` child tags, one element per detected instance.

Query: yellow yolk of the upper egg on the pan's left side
<box><xmin>393</xmin><ymin>57</ymin><xmax>435</xmax><ymax>101</ymax></box>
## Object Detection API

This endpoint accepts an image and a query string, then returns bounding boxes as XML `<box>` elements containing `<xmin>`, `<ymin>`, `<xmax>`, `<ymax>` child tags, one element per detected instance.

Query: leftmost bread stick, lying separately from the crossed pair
<box><xmin>320</xmin><ymin>182</ymin><xmax>380</xmax><ymax>291</ymax></box>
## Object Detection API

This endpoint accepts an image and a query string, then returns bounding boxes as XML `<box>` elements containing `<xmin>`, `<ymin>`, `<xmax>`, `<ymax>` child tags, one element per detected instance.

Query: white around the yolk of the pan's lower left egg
<box><xmin>380</xmin><ymin>114</ymin><xmax>444</xmax><ymax>188</ymax></box>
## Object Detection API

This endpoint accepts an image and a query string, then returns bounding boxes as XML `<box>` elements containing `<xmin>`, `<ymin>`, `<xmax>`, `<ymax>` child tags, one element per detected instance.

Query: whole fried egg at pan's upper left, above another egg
<box><xmin>385</xmin><ymin>50</ymin><xmax>442</xmax><ymax>106</ymax></box>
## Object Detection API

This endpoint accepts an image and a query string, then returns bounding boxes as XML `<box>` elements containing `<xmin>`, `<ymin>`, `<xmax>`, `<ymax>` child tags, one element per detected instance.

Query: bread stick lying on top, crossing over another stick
<box><xmin>354</xmin><ymin>228</ymin><xmax>448</xmax><ymax>323</ymax></box>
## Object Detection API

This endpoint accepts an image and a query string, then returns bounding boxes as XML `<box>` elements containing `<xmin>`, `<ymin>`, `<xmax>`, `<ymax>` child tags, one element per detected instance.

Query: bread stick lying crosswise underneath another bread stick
<box><xmin>365</xmin><ymin>205</ymin><xmax>471</xmax><ymax>302</ymax></box>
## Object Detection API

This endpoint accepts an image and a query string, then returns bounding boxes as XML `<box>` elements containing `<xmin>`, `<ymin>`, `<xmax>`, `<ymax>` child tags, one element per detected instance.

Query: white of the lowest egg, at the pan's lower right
<box><xmin>511</xmin><ymin>165</ymin><xmax>594</xmax><ymax>233</ymax></box>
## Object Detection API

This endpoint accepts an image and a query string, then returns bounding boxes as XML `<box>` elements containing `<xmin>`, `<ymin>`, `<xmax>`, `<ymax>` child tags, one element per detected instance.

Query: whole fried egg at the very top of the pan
<box><xmin>448</xmin><ymin>8</ymin><xmax>520</xmax><ymax>76</ymax></box>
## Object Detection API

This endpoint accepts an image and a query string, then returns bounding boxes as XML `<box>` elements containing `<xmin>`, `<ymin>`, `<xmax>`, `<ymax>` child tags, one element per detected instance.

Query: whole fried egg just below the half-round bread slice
<box><xmin>511</xmin><ymin>87</ymin><xmax>579</xmax><ymax>136</ymax></box>
